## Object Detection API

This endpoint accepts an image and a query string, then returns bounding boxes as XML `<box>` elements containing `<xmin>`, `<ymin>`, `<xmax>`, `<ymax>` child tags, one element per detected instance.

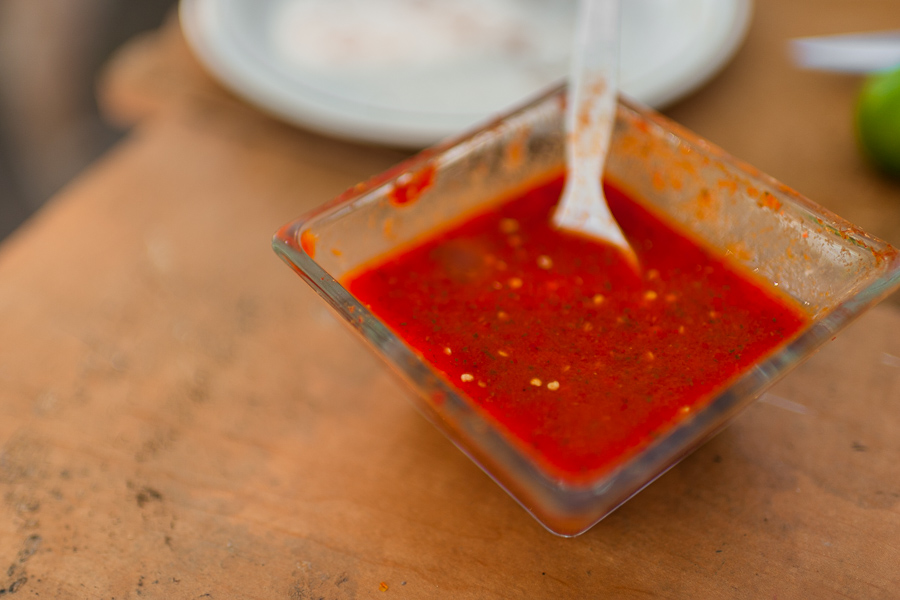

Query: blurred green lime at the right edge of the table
<box><xmin>856</xmin><ymin>69</ymin><xmax>900</xmax><ymax>177</ymax></box>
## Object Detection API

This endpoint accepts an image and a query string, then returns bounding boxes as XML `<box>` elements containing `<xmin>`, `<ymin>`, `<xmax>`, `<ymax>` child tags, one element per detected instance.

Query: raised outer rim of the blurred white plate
<box><xmin>178</xmin><ymin>0</ymin><xmax>753</xmax><ymax>149</ymax></box>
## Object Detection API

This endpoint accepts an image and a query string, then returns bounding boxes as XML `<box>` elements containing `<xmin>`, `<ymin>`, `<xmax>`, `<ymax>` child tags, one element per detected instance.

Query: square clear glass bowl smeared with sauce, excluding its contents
<box><xmin>273</xmin><ymin>88</ymin><xmax>900</xmax><ymax>536</ymax></box>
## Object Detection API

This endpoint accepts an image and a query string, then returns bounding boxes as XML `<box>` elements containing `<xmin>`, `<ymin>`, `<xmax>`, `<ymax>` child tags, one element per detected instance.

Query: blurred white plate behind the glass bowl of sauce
<box><xmin>180</xmin><ymin>0</ymin><xmax>751</xmax><ymax>147</ymax></box>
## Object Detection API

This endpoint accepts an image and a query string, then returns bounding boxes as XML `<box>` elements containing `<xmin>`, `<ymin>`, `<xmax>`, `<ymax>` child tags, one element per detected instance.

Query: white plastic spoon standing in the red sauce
<box><xmin>553</xmin><ymin>0</ymin><xmax>637</xmax><ymax>265</ymax></box>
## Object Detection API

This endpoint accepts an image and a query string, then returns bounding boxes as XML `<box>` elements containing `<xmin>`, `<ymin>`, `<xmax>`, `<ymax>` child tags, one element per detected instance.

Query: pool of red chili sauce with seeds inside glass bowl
<box><xmin>345</xmin><ymin>180</ymin><xmax>808</xmax><ymax>480</ymax></box>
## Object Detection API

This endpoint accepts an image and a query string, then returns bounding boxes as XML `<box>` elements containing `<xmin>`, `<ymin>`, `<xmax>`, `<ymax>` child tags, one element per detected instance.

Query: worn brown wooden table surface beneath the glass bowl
<box><xmin>0</xmin><ymin>0</ymin><xmax>900</xmax><ymax>600</ymax></box>
